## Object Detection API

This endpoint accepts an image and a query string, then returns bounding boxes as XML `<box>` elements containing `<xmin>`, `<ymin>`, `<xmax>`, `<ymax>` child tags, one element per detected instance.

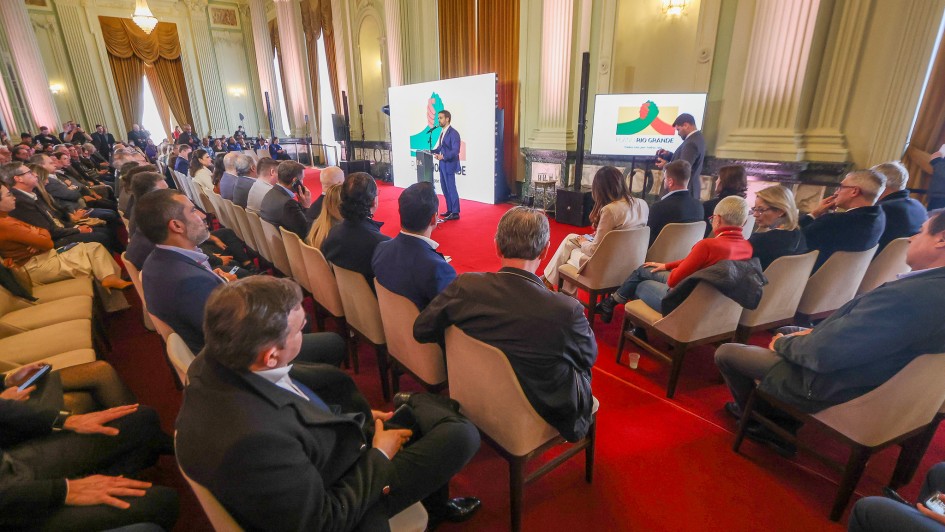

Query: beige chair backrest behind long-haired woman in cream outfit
<box><xmin>579</xmin><ymin>226</ymin><xmax>650</xmax><ymax>287</ymax></box>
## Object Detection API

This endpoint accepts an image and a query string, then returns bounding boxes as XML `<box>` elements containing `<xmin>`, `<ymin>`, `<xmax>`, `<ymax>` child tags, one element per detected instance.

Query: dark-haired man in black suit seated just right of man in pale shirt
<box><xmin>259</xmin><ymin>161</ymin><xmax>312</xmax><ymax>238</ymax></box>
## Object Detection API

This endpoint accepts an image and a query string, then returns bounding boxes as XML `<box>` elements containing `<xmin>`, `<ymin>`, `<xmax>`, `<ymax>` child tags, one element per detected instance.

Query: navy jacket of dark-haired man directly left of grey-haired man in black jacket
<box><xmin>371</xmin><ymin>233</ymin><xmax>456</xmax><ymax>310</ymax></box>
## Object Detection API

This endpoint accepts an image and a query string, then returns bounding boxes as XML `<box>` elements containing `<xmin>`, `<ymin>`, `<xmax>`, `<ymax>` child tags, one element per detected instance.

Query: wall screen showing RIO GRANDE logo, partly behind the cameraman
<box><xmin>591</xmin><ymin>93</ymin><xmax>706</xmax><ymax>156</ymax></box>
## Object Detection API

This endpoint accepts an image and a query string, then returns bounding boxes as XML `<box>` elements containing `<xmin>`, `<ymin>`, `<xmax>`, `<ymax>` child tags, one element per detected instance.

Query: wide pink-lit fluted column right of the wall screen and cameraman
<box><xmin>716</xmin><ymin>0</ymin><xmax>821</xmax><ymax>161</ymax></box>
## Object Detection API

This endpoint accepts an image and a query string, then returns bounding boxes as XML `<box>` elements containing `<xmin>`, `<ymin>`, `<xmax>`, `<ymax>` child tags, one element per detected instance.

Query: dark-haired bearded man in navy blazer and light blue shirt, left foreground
<box><xmin>135</xmin><ymin>190</ymin><xmax>346</xmax><ymax>366</ymax></box>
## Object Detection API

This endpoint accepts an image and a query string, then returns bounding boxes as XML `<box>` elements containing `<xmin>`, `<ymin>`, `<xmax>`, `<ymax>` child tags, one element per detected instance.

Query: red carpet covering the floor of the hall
<box><xmin>99</xmin><ymin>172</ymin><xmax>945</xmax><ymax>531</ymax></box>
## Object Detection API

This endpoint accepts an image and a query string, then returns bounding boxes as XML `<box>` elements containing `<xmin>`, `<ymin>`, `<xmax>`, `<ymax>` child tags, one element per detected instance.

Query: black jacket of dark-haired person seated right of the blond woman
<box><xmin>322</xmin><ymin>218</ymin><xmax>390</xmax><ymax>290</ymax></box>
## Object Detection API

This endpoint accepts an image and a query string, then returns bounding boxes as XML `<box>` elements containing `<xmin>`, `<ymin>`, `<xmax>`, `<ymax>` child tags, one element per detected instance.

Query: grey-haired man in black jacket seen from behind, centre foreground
<box><xmin>413</xmin><ymin>207</ymin><xmax>597</xmax><ymax>441</ymax></box>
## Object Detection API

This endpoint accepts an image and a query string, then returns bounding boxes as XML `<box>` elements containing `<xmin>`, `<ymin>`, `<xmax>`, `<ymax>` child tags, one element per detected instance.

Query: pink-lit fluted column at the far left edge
<box><xmin>0</xmin><ymin>0</ymin><xmax>61</xmax><ymax>130</ymax></box>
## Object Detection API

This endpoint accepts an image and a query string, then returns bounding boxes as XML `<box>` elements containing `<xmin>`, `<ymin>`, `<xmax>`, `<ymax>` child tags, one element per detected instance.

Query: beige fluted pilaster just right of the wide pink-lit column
<box><xmin>804</xmin><ymin>0</ymin><xmax>875</xmax><ymax>162</ymax></box>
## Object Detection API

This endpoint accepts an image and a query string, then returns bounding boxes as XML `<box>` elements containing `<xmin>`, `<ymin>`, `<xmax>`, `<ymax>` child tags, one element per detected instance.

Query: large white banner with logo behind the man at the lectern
<box><xmin>389</xmin><ymin>74</ymin><xmax>496</xmax><ymax>203</ymax></box>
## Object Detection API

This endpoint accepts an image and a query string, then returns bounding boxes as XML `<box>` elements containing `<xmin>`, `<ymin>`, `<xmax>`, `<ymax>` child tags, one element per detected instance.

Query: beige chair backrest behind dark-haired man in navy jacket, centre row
<box><xmin>374</xmin><ymin>279</ymin><xmax>446</xmax><ymax>385</ymax></box>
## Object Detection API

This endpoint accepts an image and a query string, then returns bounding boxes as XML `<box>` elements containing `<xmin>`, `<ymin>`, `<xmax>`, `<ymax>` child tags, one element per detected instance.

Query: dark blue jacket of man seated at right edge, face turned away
<box><xmin>761</xmin><ymin>268</ymin><xmax>945</xmax><ymax>412</ymax></box>
